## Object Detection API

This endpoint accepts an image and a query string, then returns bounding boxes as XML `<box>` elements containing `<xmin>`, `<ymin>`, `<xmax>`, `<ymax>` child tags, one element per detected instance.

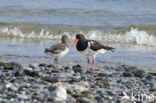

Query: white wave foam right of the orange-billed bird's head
<box><xmin>87</xmin><ymin>28</ymin><xmax>156</xmax><ymax>46</ymax></box>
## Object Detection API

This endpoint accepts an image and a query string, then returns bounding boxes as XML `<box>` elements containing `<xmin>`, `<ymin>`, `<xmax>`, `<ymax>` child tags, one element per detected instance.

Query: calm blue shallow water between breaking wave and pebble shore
<box><xmin>0</xmin><ymin>39</ymin><xmax>156</xmax><ymax>70</ymax></box>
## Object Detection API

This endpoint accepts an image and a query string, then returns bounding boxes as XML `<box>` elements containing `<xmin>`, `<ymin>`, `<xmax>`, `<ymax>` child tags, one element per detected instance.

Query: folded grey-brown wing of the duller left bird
<box><xmin>45</xmin><ymin>43</ymin><xmax>67</xmax><ymax>54</ymax></box>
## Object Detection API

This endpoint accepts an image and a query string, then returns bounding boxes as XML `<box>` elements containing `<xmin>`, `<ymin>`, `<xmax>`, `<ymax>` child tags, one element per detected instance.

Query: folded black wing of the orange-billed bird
<box><xmin>88</xmin><ymin>40</ymin><xmax>115</xmax><ymax>51</ymax></box>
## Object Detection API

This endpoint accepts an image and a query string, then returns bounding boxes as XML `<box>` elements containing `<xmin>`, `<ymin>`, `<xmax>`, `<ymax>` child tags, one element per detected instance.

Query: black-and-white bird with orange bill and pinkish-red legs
<box><xmin>72</xmin><ymin>34</ymin><xmax>115</xmax><ymax>71</ymax></box>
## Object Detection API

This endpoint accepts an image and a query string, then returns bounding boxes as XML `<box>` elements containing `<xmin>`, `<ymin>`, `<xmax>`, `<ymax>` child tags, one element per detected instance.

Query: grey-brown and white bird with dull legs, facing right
<box><xmin>44</xmin><ymin>35</ymin><xmax>70</xmax><ymax>68</ymax></box>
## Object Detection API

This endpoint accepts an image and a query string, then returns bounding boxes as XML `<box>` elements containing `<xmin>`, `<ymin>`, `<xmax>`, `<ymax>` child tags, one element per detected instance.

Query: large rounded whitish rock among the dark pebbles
<box><xmin>50</xmin><ymin>86</ymin><xmax>67</xmax><ymax>101</ymax></box>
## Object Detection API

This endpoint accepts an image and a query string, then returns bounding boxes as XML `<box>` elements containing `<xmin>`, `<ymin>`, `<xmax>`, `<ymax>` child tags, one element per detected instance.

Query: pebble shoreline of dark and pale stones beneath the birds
<box><xmin>0</xmin><ymin>62</ymin><xmax>156</xmax><ymax>103</ymax></box>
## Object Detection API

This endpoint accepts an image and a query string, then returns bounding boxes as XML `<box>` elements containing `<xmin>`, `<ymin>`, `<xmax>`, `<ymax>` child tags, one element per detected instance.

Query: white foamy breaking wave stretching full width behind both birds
<box><xmin>0</xmin><ymin>27</ymin><xmax>156</xmax><ymax>46</ymax></box>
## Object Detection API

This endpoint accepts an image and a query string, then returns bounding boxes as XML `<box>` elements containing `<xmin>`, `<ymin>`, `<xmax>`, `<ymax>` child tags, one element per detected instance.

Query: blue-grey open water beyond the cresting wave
<box><xmin>0</xmin><ymin>0</ymin><xmax>156</xmax><ymax>26</ymax></box>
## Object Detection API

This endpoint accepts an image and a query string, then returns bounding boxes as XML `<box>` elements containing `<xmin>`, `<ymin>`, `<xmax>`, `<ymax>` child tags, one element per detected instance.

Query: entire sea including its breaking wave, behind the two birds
<box><xmin>0</xmin><ymin>0</ymin><xmax>156</xmax><ymax>70</ymax></box>
